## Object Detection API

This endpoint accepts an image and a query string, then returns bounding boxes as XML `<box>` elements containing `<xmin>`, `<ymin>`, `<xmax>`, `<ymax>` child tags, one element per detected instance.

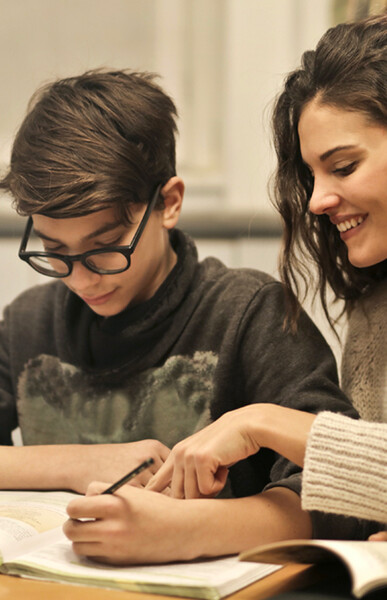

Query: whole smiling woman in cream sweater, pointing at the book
<box><xmin>144</xmin><ymin>10</ymin><xmax>387</xmax><ymax>539</ymax></box>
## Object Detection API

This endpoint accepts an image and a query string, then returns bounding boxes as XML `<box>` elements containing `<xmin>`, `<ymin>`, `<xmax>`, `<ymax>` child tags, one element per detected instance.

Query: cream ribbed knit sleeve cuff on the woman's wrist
<box><xmin>301</xmin><ymin>412</ymin><xmax>387</xmax><ymax>523</ymax></box>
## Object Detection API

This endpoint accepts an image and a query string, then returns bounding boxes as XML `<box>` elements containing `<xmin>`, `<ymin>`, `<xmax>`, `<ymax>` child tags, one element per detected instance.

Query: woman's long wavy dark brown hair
<box><xmin>273</xmin><ymin>15</ymin><xmax>387</xmax><ymax>326</ymax></box>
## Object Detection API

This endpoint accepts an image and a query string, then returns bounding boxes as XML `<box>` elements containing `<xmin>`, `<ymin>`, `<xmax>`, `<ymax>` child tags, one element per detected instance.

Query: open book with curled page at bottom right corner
<box><xmin>239</xmin><ymin>540</ymin><xmax>387</xmax><ymax>598</ymax></box>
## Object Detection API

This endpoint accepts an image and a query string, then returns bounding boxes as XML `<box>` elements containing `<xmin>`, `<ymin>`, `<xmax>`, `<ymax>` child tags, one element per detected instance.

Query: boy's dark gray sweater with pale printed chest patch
<box><xmin>0</xmin><ymin>231</ymin><xmax>376</xmax><ymax>538</ymax></box>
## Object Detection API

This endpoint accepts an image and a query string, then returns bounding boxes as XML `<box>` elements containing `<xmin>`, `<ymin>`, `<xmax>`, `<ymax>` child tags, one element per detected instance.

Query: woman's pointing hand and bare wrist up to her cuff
<box><xmin>146</xmin><ymin>404</ymin><xmax>315</xmax><ymax>498</ymax></box>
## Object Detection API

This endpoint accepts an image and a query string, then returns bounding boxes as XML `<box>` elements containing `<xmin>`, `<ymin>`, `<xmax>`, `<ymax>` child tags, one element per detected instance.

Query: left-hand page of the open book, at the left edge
<box><xmin>0</xmin><ymin>491</ymin><xmax>75</xmax><ymax>562</ymax></box>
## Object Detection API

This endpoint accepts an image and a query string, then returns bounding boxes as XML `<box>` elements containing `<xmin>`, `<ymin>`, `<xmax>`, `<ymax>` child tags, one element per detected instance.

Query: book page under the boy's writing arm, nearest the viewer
<box><xmin>7</xmin><ymin>536</ymin><xmax>280</xmax><ymax>598</ymax></box>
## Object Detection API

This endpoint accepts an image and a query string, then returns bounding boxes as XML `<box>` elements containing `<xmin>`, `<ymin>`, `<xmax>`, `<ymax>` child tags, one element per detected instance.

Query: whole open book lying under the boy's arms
<box><xmin>0</xmin><ymin>491</ymin><xmax>280</xmax><ymax>600</ymax></box>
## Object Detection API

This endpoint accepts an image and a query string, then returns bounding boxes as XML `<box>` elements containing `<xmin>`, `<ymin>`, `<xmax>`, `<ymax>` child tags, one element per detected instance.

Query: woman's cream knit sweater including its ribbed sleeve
<box><xmin>302</xmin><ymin>281</ymin><xmax>387</xmax><ymax>523</ymax></box>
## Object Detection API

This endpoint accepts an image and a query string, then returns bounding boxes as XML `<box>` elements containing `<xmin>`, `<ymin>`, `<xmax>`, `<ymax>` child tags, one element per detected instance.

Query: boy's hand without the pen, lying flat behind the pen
<box><xmin>67</xmin><ymin>440</ymin><xmax>170</xmax><ymax>494</ymax></box>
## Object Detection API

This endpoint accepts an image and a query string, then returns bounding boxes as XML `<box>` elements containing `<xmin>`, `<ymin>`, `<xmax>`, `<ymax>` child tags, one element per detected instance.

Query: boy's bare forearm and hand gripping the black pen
<box><xmin>63</xmin><ymin>483</ymin><xmax>312</xmax><ymax>565</ymax></box>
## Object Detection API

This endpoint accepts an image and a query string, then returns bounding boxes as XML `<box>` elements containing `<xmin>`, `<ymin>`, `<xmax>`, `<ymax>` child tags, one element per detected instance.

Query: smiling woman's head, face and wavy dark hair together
<box><xmin>273</xmin><ymin>15</ymin><xmax>387</xmax><ymax>325</ymax></box>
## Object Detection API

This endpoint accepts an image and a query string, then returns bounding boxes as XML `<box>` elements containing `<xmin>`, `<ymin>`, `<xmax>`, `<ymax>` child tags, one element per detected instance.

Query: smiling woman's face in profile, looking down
<box><xmin>298</xmin><ymin>99</ymin><xmax>387</xmax><ymax>267</ymax></box>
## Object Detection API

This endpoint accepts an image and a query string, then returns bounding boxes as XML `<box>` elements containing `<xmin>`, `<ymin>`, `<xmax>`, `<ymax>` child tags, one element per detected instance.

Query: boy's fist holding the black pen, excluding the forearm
<box><xmin>63</xmin><ymin>482</ymin><xmax>195</xmax><ymax>565</ymax></box>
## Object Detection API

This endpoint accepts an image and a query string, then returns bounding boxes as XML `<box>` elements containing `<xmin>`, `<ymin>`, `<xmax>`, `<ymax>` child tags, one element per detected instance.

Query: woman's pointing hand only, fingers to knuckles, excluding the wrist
<box><xmin>146</xmin><ymin>405</ymin><xmax>260</xmax><ymax>498</ymax></box>
